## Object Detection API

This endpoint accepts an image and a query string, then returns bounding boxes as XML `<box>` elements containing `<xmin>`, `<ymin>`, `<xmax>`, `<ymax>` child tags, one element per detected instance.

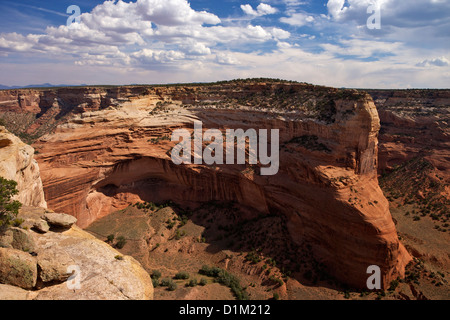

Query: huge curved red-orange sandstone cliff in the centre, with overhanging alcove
<box><xmin>7</xmin><ymin>84</ymin><xmax>410</xmax><ymax>287</ymax></box>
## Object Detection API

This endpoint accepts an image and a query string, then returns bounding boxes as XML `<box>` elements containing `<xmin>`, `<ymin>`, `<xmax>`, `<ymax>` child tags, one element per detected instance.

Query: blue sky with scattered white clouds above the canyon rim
<box><xmin>0</xmin><ymin>0</ymin><xmax>450</xmax><ymax>88</ymax></box>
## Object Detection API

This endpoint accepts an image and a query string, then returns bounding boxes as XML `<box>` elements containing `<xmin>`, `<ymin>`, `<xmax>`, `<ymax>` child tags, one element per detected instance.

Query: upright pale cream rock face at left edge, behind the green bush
<box><xmin>0</xmin><ymin>126</ymin><xmax>47</xmax><ymax>208</ymax></box>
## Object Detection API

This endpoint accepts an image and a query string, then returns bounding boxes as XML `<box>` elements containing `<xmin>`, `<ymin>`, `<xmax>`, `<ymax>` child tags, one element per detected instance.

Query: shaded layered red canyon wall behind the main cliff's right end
<box><xmin>369</xmin><ymin>90</ymin><xmax>450</xmax><ymax>183</ymax></box>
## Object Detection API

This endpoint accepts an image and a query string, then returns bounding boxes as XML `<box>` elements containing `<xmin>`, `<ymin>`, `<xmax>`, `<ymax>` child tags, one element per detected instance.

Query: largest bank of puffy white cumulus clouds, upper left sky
<box><xmin>0</xmin><ymin>0</ymin><xmax>290</xmax><ymax>68</ymax></box>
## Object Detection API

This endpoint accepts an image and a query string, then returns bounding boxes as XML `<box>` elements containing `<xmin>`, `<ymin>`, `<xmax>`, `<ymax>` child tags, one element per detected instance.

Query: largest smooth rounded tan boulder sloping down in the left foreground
<box><xmin>34</xmin><ymin>226</ymin><xmax>153</xmax><ymax>300</ymax></box>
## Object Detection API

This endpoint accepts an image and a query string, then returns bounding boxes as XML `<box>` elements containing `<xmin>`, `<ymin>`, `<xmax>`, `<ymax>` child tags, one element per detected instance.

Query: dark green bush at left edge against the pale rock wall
<box><xmin>0</xmin><ymin>177</ymin><xmax>22</xmax><ymax>227</ymax></box>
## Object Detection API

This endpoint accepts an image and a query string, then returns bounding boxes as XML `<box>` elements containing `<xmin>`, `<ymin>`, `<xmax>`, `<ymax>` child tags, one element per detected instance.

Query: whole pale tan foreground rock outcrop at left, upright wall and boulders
<box><xmin>0</xmin><ymin>127</ymin><xmax>153</xmax><ymax>300</ymax></box>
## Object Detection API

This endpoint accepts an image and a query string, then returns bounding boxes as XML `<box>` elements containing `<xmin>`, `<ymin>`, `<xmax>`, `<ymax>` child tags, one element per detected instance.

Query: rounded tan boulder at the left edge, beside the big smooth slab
<box><xmin>0</xmin><ymin>248</ymin><xmax>38</xmax><ymax>289</ymax></box>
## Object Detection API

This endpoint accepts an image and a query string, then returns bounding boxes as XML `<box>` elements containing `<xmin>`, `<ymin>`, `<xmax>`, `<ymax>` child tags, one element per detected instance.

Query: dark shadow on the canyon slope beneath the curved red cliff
<box><xmin>92</xmin><ymin>174</ymin><xmax>348</xmax><ymax>291</ymax></box>
